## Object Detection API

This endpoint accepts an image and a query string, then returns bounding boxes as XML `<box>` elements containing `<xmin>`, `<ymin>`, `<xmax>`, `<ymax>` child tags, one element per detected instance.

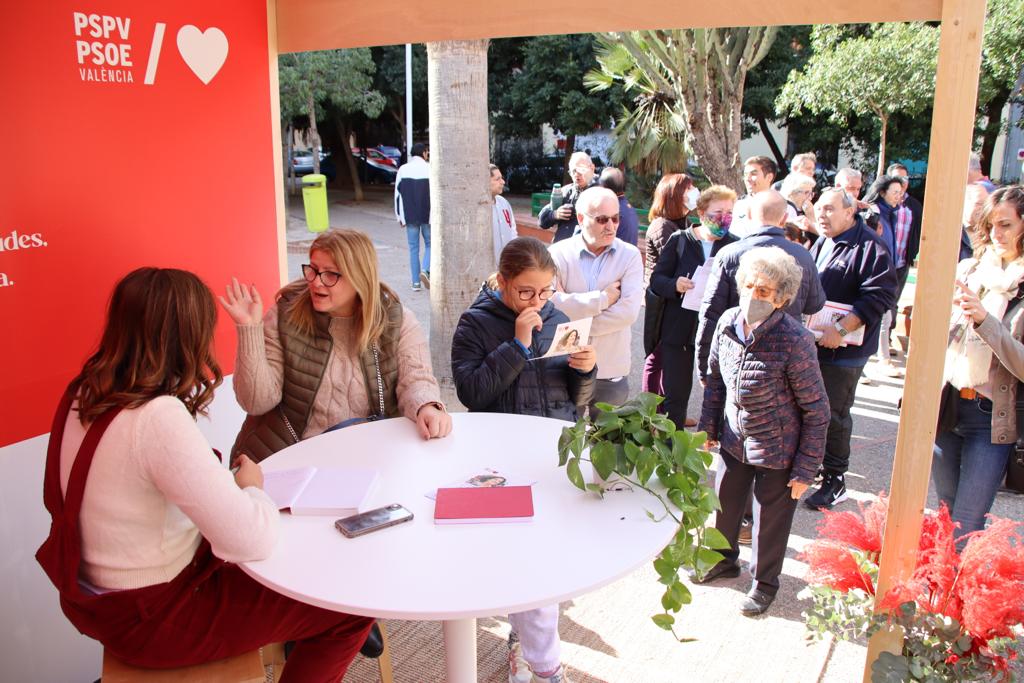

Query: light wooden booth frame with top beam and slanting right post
<box><xmin>267</xmin><ymin>0</ymin><xmax>987</xmax><ymax>681</ymax></box>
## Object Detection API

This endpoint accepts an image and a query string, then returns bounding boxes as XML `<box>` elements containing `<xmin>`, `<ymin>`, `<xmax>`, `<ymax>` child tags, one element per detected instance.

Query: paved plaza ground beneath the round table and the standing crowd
<box><xmin>288</xmin><ymin>187</ymin><xmax>1024</xmax><ymax>683</ymax></box>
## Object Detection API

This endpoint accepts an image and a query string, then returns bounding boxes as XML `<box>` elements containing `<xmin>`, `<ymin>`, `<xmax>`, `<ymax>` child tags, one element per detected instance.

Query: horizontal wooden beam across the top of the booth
<box><xmin>278</xmin><ymin>0</ymin><xmax>942</xmax><ymax>52</ymax></box>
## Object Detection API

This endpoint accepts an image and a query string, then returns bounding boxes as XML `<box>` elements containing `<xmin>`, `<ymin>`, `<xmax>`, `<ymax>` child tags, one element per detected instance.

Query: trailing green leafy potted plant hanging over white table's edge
<box><xmin>558</xmin><ymin>393</ymin><xmax>716</xmax><ymax>637</ymax></box>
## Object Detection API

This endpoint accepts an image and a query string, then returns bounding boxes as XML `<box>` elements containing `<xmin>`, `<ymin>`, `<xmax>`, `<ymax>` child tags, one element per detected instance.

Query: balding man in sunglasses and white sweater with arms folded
<box><xmin>551</xmin><ymin>187</ymin><xmax>643</xmax><ymax>412</ymax></box>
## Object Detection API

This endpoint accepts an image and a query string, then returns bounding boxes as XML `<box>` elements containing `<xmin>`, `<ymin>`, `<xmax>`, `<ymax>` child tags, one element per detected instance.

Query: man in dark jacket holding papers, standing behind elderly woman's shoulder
<box><xmin>806</xmin><ymin>188</ymin><xmax>896</xmax><ymax>510</ymax></box>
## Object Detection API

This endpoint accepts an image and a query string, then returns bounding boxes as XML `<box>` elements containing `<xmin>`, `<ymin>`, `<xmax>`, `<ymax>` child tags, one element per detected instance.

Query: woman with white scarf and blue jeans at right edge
<box><xmin>932</xmin><ymin>185</ymin><xmax>1024</xmax><ymax>537</ymax></box>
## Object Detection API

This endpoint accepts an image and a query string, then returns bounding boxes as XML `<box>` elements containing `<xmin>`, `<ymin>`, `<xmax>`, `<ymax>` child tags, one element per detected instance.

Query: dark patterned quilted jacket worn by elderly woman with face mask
<box><xmin>699</xmin><ymin>307</ymin><xmax>828</xmax><ymax>484</ymax></box>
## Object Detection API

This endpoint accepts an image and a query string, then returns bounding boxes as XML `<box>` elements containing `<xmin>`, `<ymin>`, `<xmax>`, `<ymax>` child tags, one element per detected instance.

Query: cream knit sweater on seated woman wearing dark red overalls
<box><xmin>60</xmin><ymin>396</ymin><xmax>280</xmax><ymax>590</ymax></box>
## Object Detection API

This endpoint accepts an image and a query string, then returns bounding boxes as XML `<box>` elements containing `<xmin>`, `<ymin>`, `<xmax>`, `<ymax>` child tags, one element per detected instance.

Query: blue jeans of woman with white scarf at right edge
<box><xmin>932</xmin><ymin>398</ymin><xmax>1015</xmax><ymax>536</ymax></box>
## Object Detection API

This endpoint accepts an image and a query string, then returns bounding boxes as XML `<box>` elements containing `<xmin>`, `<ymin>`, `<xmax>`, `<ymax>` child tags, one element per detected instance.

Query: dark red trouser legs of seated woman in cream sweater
<box><xmin>113</xmin><ymin>564</ymin><xmax>374</xmax><ymax>683</ymax></box>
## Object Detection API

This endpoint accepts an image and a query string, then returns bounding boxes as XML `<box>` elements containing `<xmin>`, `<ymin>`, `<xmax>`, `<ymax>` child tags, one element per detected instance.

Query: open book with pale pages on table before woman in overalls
<box><xmin>263</xmin><ymin>467</ymin><xmax>378</xmax><ymax>517</ymax></box>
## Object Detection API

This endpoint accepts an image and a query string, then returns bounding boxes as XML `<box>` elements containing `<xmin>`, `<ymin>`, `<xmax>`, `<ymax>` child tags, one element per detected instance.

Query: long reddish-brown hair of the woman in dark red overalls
<box><xmin>72</xmin><ymin>268</ymin><xmax>223</xmax><ymax>424</ymax></box>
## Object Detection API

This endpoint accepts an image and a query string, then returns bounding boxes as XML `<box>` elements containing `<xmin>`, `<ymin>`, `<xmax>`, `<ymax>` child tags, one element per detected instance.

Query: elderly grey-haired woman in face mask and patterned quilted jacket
<box><xmin>694</xmin><ymin>247</ymin><xmax>828</xmax><ymax>615</ymax></box>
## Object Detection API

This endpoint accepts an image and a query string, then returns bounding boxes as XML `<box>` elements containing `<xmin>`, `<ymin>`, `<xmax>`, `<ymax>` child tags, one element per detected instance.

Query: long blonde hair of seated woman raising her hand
<box><xmin>278</xmin><ymin>228</ymin><xmax>399</xmax><ymax>352</ymax></box>
